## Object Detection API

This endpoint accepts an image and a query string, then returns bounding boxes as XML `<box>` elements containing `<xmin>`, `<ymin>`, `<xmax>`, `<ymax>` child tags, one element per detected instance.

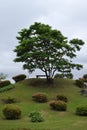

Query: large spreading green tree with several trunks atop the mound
<box><xmin>14</xmin><ymin>22</ymin><xmax>84</xmax><ymax>80</ymax></box>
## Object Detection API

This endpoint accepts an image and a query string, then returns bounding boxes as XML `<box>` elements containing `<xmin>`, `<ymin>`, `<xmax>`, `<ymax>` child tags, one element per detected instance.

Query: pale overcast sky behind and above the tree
<box><xmin>0</xmin><ymin>0</ymin><xmax>87</xmax><ymax>81</ymax></box>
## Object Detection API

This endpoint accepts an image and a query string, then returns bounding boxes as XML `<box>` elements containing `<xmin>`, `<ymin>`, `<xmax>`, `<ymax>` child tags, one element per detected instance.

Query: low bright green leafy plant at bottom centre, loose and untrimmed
<box><xmin>29</xmin><ymin>112</ymin><xmax>44</xmax><ymax>122</ymax></box>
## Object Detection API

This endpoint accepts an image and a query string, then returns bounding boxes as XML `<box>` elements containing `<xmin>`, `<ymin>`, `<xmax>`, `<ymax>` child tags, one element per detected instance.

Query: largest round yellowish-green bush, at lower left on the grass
<box><xmin>3</xmin><ymin>104</ymin><xmax>21</xmax><ymax>120</ymax></box>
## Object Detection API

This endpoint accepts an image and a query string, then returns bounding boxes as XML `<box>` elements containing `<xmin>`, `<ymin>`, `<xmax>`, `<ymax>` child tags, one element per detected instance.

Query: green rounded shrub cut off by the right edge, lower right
<box><xmin>76</xmin><ymin>105</ymin><xmax>87</xmax><ymax>116</ymax></box>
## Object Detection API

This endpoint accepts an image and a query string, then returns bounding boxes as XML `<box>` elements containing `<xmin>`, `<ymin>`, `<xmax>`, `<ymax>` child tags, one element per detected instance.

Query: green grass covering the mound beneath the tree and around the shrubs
<box><xmin>0</xmin><ymin>79</ymin><xmax>87</xmax><ymax>130</ymax></box>
